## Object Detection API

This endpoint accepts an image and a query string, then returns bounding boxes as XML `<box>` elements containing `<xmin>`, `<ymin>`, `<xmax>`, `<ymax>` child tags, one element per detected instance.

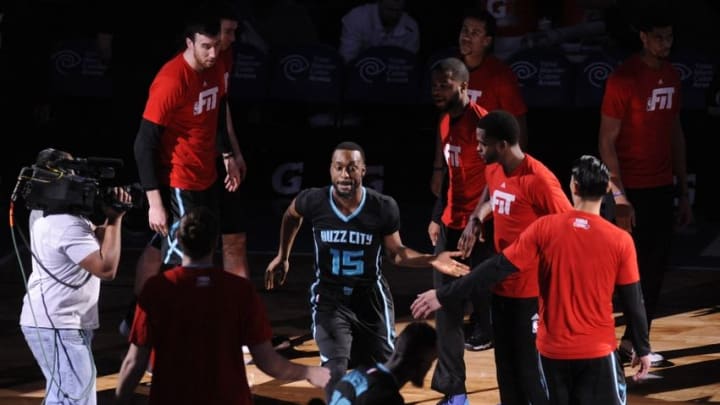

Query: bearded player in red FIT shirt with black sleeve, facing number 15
<box><xmin>428</xmin><ymin>58</ymin><xmax>491</xmax><ymax>403</ymax></box>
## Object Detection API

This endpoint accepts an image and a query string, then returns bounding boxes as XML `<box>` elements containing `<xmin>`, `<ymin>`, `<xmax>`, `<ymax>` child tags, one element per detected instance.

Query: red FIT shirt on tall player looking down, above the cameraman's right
<box><xmin>143</xmin><ymin>53</ymin><xmax>225</xmax><ymax>191</ymax></box>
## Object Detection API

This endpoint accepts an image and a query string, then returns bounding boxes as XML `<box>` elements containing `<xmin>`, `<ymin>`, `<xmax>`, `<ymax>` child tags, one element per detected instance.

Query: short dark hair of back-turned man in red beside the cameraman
<box><xmin>177</xmin><ymin>206</ymin><xmax>220</xmax><ymax>260</ymax></box>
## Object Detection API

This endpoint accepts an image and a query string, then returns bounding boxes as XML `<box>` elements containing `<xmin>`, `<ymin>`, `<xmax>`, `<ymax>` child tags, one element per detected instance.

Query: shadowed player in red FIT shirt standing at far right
<box><xmin>599</xmin><ymin>9</ymin><xmax>692</xmax><ymax>364</ymax></box>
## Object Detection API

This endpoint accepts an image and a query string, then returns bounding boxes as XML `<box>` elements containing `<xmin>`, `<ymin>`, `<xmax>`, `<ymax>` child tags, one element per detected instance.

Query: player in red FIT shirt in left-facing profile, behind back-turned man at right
<box><xmin>461</xmin><ymin>110</ymin><xmax>572</xmax><ymax>404</ymax></box>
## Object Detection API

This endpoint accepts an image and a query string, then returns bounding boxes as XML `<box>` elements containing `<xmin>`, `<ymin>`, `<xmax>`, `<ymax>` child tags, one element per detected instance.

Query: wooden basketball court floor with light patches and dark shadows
<box><xmin>0</xmin><ymin>251</ymin><xmax>720</xmax><ymax>405</ymax></box>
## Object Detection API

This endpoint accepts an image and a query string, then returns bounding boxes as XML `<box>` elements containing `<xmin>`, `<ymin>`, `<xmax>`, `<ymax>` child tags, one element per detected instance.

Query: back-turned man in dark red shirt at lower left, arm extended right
<box><xmin>116</xmin><ymin>206</ymin><xmax>330</xmax><ymax>404</ymax></box>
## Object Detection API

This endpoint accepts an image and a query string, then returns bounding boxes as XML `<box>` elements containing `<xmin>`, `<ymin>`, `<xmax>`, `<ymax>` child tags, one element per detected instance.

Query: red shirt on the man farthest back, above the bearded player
<box><xmin>468</xmin><ymin>55</ymin><xmax>527</xmax><ymax>117</ymax></box>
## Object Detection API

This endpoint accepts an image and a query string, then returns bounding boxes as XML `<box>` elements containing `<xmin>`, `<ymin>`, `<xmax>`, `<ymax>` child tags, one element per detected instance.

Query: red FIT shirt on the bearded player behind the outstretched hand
<box><xmin>438</xmin><ymin>101</ymin><xmax>487</xmax><ymax>229</ymax></box>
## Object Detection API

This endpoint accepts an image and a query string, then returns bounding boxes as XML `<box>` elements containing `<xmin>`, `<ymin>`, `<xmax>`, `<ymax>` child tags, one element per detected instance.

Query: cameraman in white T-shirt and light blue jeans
<box><xmin>20</xmin><ymin>149</ymin><xmax>131</xmax><ymax>404</ymax></box>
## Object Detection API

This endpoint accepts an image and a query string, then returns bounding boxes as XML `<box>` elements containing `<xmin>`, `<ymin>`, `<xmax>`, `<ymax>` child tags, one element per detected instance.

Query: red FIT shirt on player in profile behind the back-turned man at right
<box><xmin>485</xmin><ymin>153</ymin><xmax>572</xmax><ymax>298</ymax></box>
